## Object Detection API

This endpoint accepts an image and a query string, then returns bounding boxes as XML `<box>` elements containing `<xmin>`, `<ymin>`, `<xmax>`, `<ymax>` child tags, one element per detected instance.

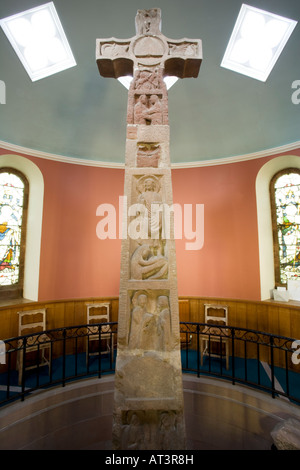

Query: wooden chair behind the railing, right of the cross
<box><xmin>199</xmin><ymin>304</ymin><xmax>229</xmax><ymax>369</ymax></box>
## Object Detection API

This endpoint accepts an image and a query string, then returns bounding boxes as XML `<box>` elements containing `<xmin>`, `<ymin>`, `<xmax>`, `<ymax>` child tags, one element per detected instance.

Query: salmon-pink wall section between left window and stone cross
<box><xmin>38</xmin><ymin>160</ymin><xmax>124</xmax><ymax>300</ymax></box>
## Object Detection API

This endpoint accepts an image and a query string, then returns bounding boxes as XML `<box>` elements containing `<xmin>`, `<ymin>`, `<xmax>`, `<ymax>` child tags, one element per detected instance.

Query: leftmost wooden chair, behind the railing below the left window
<box><xmin>17</xmin><ymin>308</ymin><xmax>51</xmax><ymax>385</ymax></box>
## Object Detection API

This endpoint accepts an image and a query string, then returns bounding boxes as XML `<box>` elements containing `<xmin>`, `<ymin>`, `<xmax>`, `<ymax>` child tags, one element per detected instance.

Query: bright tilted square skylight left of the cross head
<box><xmin>0</xmin><ymin>2</ymin><xmax>76</xmax><ymax>81</ymax></box>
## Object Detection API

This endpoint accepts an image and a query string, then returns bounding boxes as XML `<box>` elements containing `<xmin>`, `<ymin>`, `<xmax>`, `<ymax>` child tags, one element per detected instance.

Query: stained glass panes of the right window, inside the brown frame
<box><xmin>274</xmin><ymin>173</ymin><xmax>300</xmax><ymax>284</ymax></box>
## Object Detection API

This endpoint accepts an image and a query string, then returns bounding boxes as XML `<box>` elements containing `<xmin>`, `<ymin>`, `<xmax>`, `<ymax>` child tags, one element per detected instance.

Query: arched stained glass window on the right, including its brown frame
<box><xmin>271</xmin><ymin>169</ymin><xmax>300</xmax><ymax>286</ymax></box>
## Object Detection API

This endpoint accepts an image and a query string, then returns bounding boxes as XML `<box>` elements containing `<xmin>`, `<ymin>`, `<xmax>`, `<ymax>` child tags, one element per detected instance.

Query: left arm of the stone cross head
<box><xmin>96</xmin><ymin>37</ymin><xmax>134</xmax><ymax>78</ymax></box>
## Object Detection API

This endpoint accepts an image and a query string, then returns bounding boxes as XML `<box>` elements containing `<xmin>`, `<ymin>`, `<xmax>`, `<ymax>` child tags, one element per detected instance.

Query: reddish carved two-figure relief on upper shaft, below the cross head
<box><xmin>133</xmin><ymin>94</ymin><xmax>163</xmax><ymax>126</ymax></box>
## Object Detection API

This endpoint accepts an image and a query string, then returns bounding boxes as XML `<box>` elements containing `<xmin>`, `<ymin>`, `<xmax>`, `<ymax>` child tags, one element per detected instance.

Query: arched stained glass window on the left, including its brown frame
<box><xmin>0</xmin><ymin>168</ymin><xmax>28</xmax><ymax>298</ymax></box>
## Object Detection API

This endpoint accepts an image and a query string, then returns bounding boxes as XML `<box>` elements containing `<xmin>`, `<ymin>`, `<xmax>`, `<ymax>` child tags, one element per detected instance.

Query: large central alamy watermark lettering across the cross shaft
<box><xmin>96</xmin><ymin>196</ymin><xmax>204</xmax><ymax>250</ymax></box>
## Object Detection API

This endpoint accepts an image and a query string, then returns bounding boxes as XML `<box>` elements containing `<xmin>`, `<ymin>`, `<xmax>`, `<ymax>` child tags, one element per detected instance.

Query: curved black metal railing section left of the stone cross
<box><xmin>0</xmin><ymin>322</ymin><xmax>118</xmax><ymax>404</ymax></box>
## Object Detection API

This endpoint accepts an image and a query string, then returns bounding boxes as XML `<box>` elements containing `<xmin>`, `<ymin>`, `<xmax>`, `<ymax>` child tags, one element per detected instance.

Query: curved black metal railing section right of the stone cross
<box><xmin>180</xmin><ymin>322</ymin><xmax>300</xmax><ymax>404</ymax></box>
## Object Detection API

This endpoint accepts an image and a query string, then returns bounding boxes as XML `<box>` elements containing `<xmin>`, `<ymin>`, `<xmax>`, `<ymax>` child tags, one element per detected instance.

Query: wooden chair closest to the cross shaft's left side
<box><xmin>86</xmin><ymin>302</ymin><xmax>114</xmax><ymax>366</ymax></box>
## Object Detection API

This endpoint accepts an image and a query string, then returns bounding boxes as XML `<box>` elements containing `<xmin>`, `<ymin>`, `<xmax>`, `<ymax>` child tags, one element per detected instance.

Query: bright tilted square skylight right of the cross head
<box><xmin>221</xmin><ymin>4</ymin><xmax>297</xmax><ymax>82</ymax></box>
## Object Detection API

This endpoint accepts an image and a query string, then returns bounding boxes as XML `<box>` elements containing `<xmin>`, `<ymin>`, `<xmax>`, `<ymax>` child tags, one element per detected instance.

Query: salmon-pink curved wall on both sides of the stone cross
<box><xmin>0</xmin><ymin>150</ymin><xmax>300</xmax><ymax>301</ymax></box>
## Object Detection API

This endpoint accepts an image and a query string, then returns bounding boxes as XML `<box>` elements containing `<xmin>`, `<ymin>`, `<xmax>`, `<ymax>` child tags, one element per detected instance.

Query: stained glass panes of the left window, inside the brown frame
<box><xmin>0</xmin><ymin>172</ymin><xmax>24</xmax><ymax>286</ymax></box>
